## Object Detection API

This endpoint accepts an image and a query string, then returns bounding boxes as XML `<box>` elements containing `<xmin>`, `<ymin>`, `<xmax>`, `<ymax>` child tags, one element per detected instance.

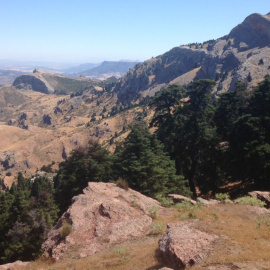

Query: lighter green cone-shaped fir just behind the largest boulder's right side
<box><xmin>115</xmin><ymin>123</ymin><xmax>188</xmax><ymax>197</ymax></box>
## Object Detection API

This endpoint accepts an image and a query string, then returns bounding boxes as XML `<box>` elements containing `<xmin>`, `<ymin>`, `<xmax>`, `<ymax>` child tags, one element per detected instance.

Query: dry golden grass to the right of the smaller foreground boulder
<box><xmin>194</xmin><ymin>205</ymin><xmax>270</xmax><ymax>269</ymax></box>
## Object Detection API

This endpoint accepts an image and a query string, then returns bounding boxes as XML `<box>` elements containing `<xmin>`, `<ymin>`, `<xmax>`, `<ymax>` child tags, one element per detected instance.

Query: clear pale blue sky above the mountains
<box><xmin>0</xmin><ymin>0</ymin><xmax>270</xmax><ymax>63</ymax></box>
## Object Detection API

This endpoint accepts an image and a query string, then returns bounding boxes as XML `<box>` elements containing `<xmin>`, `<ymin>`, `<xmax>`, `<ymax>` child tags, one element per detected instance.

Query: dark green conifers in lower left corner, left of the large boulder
<box><xmin>0</xmin><ymin>173</ymin><xmax>58</xmax><ymax>263</ymax></box>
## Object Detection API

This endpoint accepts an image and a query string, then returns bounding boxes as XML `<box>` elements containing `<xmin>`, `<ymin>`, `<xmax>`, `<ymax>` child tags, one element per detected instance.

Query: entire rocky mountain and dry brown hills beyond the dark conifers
<box><xmin>0</xmin><ymin>14</ymin><xmax>270</xmax><ymax>186</ymax></box>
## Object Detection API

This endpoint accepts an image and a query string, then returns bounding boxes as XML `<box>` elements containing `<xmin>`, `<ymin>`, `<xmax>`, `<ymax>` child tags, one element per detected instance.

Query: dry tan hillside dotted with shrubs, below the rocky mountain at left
<box><xmin>0</xmin><ymin>86</ymin><xmax>152</xmax><ymax>182</ymax></box>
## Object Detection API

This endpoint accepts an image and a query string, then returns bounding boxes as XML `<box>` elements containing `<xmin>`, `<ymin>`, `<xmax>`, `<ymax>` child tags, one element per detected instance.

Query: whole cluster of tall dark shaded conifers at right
<box><xmin>150</xmin><ymin>76</ymin><xmax>270</xmax><ymax>195</ymax></box>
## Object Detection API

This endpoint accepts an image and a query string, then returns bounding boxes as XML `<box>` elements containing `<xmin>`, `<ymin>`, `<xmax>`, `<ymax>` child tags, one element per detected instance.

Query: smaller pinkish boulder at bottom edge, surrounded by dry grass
<box><xmin>159</xmin><ymin>222</ymin><xmax>218</xmax><ymax>270</ymax></box>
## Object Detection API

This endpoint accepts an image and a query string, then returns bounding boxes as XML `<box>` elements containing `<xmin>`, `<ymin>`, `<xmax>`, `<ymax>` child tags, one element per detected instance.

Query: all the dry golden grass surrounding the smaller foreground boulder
<box><xmin>18</xmin><ymin>204</ymin><xmax>270</xmax><ymax>270</ymax></box>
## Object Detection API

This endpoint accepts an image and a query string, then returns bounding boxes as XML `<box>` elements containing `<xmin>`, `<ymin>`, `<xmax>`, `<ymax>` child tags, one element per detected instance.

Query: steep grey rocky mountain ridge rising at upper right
<box><xmin>115</xmin><ymin>14</ymin><xmax>270</xmax><ymax>103</ymax></box>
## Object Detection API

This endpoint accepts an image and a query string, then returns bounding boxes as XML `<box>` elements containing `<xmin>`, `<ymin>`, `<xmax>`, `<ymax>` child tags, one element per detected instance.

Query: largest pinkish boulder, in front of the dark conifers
<box><xmin>43</xmin><ymin>182</ymin><xmax>160</xmax><ymax>260</ymax></box>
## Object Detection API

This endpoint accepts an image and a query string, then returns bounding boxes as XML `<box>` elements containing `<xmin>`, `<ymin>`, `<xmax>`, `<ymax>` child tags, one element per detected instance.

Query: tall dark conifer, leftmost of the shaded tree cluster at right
<box><xmin>153</xmin><ymin>80</ymin><xmax>218</xmax><ymax>193</ymax></box>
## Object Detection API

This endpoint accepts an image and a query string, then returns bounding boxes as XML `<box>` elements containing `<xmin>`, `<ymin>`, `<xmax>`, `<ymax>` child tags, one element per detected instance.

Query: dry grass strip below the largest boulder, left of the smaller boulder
<box><xmin>25</xmin><ymin>236</ymin><xmax>168</xmax><ymax>270</ymax></box>
